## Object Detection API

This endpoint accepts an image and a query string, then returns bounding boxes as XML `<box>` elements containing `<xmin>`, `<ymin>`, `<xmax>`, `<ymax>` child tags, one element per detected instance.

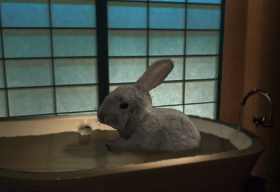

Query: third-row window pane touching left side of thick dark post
<box><xmin>55</xmin><ymin>59</ymin><xmax>97</xmax><ymax>85</ymax></box>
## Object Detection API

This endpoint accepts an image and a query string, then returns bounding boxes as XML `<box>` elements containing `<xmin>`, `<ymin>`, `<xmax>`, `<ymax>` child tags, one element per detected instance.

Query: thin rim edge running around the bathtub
<box><xmin>0</xmin><ymin>115</ymin><xmax>264</xmax><ymax>181</ymax></box>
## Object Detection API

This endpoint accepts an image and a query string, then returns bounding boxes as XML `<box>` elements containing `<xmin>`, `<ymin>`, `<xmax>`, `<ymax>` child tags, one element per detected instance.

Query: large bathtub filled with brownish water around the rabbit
<box><xmin>0</xmin><ymin>116</ymin><xmax>262</xmax><ymax>192</ymax></box>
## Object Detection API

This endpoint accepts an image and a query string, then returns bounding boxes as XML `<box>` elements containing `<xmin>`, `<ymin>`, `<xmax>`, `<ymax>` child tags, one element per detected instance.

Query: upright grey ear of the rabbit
<box><xmin>136</xmin><ymin>59</ymin><xmax>173</xmax><ymax>91</ymax></box>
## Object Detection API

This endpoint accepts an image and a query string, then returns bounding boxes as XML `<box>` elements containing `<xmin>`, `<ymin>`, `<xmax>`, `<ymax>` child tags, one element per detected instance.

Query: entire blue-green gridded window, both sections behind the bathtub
<box><xmin>0</xmin><ymin>0</ymin><xmax>224</xmax><ymax>118</ymax></box>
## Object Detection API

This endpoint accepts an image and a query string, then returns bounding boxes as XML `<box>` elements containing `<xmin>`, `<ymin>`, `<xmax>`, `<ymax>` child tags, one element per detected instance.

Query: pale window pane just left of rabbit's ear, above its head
<box><xmin>109</xmin><ymin>58</ymin><xmax>146</xmax><ymax>83</ymax></box>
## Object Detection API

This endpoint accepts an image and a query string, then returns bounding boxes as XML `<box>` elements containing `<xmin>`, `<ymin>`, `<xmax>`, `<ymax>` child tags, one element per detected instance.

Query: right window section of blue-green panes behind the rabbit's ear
<box><xmin>108</xmin><ymin>0</ymin><xmax>224</xmax><ymax>118</ymax></box>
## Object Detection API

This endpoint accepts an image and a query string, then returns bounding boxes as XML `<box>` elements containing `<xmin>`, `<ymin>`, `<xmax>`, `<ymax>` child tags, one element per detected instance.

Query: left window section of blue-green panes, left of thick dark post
<box><xmin>0</xmin><ymin>0</ymin><xmax>98</xmax><ymax>117</ymax></box>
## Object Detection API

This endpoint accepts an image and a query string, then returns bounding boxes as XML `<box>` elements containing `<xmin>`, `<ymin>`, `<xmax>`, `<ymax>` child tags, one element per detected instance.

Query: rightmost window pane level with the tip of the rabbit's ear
<box><xmin>185</xmin><ymin>57</ymin><xmax>218</xmax><ymax>79</ymax></box>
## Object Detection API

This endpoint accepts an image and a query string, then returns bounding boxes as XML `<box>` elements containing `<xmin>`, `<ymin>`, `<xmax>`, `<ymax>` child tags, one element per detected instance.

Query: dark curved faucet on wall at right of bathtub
<box><xmin>239</xmin><ymin>89</ymin><xmax>272</xmax><ymax>129</ymax></box>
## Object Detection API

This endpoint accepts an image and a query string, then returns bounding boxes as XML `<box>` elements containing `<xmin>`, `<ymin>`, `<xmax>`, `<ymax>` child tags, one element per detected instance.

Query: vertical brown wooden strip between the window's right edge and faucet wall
<box><xmin>220</xmin><ymin>0</ymin><xmax>247</xmax><ymax>123</ymax></box>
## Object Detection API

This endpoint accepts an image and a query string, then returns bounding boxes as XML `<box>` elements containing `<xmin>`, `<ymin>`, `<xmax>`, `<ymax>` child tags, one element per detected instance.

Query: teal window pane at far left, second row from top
<box><xmin>3</xmin><ymin>29</ymin><xmax>50</xmax><ymax>58</ymax></box>
